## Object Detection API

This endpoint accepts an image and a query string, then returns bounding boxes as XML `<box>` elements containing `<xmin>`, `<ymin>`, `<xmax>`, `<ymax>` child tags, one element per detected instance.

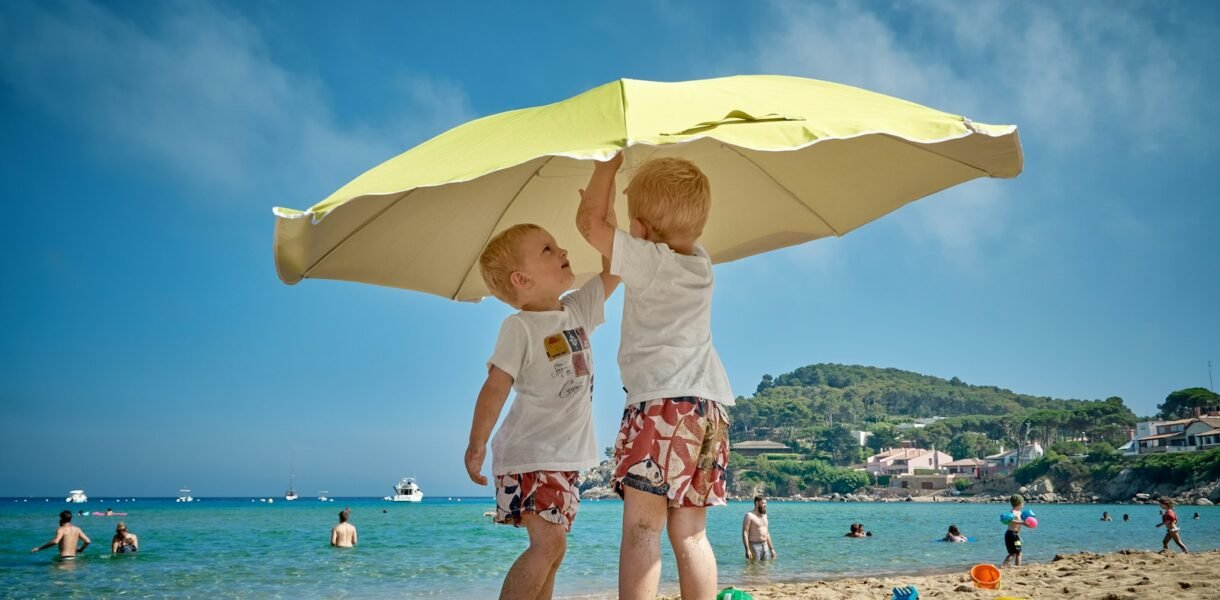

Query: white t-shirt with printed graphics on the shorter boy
<box><xmin>487</xmin><ymin>276</ymin><xmax>605</xmax><ymax>476</ymax></box>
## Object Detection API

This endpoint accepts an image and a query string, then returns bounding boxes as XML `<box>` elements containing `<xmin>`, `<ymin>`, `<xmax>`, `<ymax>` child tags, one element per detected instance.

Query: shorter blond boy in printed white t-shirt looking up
<box><xmin>466</xmin><ymin>214</ymin><xmax>619</xmax><ymax>600</ymax></box>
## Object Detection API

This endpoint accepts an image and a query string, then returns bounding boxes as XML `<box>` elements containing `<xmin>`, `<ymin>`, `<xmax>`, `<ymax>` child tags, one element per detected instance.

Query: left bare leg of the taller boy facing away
<box><xmin>619</xmin><ymin>485</ymin><xmax>669</xmax><ymax>600</ymax></box>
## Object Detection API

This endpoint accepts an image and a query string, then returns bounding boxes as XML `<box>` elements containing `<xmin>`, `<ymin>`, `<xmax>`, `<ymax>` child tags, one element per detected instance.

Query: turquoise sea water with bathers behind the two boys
<box><xmin>0</xmin><ymin>498</ymin><xmax>1220</xmax><ymax>599</ymax></box>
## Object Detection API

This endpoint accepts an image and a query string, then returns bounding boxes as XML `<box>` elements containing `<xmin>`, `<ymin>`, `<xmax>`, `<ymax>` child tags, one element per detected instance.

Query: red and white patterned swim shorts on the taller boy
<box><xmin>614</xmin><ymin>396</ymin><xmax>728</xmax><ymax>509</ymax></box>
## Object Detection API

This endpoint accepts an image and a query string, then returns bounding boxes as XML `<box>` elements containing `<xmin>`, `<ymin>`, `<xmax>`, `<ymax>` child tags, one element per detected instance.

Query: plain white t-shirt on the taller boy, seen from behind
<box><xmin>610</xmin><ymin>229</ymin><xmax>734</xmax><ymax>406</ymax></box>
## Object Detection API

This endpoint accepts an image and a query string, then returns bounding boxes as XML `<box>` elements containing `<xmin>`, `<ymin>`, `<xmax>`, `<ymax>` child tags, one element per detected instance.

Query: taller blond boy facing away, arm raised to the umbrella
<box><xmin>576</xmin><ymin>154</ymin><xmax>733</xmax><ymax>600</ymax></box>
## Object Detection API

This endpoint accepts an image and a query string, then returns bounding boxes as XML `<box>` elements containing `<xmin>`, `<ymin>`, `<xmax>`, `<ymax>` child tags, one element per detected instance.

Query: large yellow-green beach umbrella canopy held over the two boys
<box><xmin>275</xmin><ymin>76</ymin><xmax>1022</xmax><ymax>300</ymax></box>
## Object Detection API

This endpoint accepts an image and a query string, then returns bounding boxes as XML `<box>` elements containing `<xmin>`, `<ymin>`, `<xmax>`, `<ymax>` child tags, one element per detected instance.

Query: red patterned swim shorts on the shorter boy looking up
<box><xmin>495</xmin><ymin>471</ymin><xmax>581</xmax><ymax>532</ymax></box>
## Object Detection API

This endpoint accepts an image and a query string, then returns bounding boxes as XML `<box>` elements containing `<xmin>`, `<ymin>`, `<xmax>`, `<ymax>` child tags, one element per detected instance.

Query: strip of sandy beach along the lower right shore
<box><xmin>702</xmin><ymin>550</ymin><xmax>1220</xmax><ymax>600</ymax></box>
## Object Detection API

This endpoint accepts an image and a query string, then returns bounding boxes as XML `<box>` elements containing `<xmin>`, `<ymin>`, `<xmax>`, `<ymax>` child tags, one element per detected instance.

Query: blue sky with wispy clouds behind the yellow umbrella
<box><xmin>0</xmin><ymin>0</ymin><xmax>1220</xmax><ymax>498</ymax></box>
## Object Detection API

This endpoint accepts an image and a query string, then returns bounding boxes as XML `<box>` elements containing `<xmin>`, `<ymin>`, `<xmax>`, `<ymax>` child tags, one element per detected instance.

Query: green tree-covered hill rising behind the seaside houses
<box><xmin>730</xmin><ymin>363</ymin><xmax>1136</xmax><ymax>462</ymax></box>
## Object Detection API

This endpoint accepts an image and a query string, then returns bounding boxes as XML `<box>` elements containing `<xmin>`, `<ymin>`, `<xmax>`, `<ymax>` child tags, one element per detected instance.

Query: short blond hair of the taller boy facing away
<box><xmin>627</xmin><ymin>159</ymin><xmax>711</xmax><ymax>240</ymax></box>
